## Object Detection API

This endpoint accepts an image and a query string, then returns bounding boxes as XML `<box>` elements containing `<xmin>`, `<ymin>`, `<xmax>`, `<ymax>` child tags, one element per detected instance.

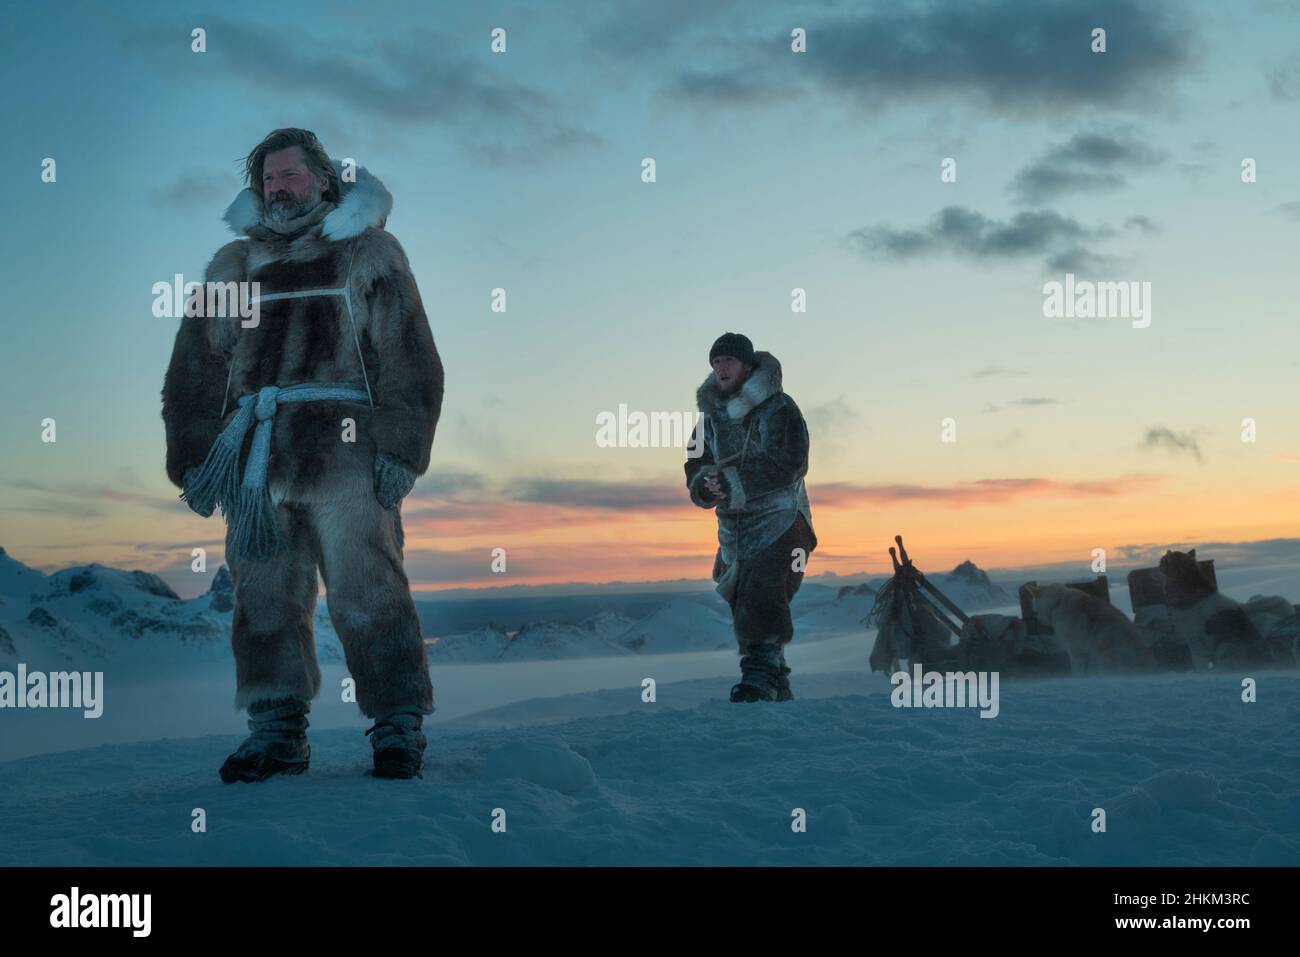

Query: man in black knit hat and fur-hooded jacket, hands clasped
<box><xmin>686</xmin><ymin>333</ymin><xmax>816</xmax><ymax>701</ymax></box>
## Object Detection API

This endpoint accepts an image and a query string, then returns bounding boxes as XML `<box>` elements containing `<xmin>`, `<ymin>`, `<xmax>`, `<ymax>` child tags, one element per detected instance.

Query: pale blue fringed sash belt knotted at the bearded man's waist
<box><xmin>181</xmin><ymin>382</ymin><xmax>371</xmax><ymax>560</ymax></box>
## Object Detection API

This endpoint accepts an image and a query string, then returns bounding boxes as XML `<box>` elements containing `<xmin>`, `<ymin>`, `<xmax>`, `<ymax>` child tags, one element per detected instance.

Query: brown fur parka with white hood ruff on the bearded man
<box><xmin>163</xmin><ymin>164</ymin><xmax>443</xmax><ymax>501</ymax></box>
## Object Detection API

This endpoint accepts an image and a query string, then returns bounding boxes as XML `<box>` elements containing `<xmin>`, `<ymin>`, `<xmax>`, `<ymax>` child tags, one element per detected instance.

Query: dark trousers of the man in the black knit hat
<box><xmin>714</xmin><ymin>514</ymin><xmax>816</xmax><ymax>654</ymax></box>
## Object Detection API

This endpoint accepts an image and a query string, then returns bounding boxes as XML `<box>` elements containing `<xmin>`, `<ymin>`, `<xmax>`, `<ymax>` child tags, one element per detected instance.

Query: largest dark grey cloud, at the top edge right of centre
<box><xmin>668</xmin><ymin>0</ymin><xmax>1192</xmax><ymax>117</ymax></box>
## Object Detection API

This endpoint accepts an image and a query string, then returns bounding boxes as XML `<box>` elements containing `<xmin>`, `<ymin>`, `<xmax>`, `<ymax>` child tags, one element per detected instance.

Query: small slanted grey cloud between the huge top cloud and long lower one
<box><xmin>1010</xmin><ymin>131</ymin><xmax>1165</xmax><ymax>203</ymax></box>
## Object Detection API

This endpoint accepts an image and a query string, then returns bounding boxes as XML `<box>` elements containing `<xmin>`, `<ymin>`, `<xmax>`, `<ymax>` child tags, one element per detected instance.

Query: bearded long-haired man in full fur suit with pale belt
<box><xmin>163</xmin><ymin>129</ymin><xmax>443</xmax><ymax>783</ymax></box>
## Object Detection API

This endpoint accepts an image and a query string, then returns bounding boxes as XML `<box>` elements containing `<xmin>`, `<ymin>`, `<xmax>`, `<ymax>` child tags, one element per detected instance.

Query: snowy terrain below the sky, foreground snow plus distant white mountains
<box><xmin>0</xmin><ymin>546</ymin><xmax>1300</xmax><ymax>865</ymax></box>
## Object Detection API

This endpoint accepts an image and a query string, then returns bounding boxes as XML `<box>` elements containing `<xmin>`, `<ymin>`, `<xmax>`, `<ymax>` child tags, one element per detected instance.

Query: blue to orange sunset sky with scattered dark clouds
<box><xmin>0</xmin><ymin>0</ymin><xmax>1300</xmax><ymax>594</ymax></box>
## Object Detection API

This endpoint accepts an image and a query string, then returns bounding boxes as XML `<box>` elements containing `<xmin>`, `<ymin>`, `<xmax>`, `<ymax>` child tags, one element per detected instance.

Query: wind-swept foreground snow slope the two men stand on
<box><xmin>0</xmin><ymin>657</ymin><xmax>1300</xmax><ymax>865</ymax></box>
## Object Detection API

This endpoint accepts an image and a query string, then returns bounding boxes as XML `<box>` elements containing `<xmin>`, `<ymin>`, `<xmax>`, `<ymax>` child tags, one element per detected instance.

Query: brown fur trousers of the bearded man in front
<box><xmin>230</xmin><ymin>488</ymin><xmax>433</xmax><ymax>718</ymax></box>
